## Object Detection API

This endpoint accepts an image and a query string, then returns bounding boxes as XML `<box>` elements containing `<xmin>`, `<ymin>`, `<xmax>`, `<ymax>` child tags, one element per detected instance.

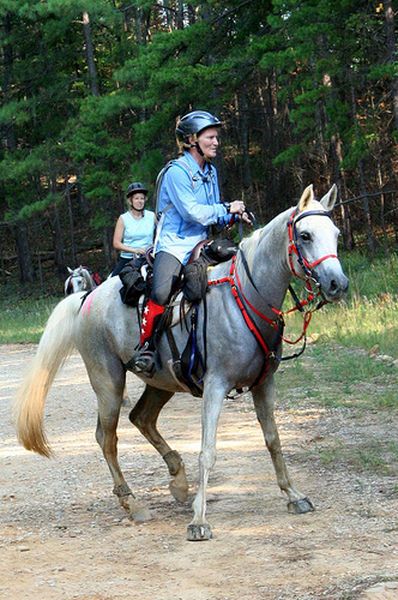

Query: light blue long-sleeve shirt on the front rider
<box><xmin>156</xmin><ymin>152</ymin><xmax>231</xmax><ymax>264</ymax></box>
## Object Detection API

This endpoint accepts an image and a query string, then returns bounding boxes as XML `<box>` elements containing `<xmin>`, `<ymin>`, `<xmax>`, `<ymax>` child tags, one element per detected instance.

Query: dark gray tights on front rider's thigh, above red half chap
<box><xmin>151</xmin><ymin>252</ymin><xmax>183</xmax><ymax>306</ymax></box>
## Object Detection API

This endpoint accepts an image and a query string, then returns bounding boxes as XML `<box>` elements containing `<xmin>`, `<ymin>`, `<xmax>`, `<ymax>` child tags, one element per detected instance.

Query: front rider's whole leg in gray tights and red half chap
<box><xmin>133</xmin><ymin>252</ymin><xmax>182</xmax><ymax>375</ymax></box>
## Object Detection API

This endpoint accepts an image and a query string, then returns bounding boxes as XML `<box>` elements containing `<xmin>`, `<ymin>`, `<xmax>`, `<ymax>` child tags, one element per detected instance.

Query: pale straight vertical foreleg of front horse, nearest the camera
<box><xmin>187</xmin><ymin>384</ymin><xmax>225</xmax><ymax>542</ymax></box>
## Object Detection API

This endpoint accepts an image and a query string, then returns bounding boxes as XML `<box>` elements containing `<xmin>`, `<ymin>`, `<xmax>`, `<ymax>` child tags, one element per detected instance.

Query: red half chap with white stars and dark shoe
<box><xmin>132</xmin><ymin>299</ymin><xmax>166</xmax><ymax>377</ymax></box>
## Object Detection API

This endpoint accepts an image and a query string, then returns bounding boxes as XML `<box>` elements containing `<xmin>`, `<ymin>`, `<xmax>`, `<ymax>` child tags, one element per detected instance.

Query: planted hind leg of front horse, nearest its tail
<box><xmin>87</xmin><ymin>357</ymin><xmax>151</xmax><ymax>522</ymax></box>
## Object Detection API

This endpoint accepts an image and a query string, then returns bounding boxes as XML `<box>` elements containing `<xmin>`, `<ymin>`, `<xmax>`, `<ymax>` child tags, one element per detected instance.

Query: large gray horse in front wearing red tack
<box><xmin>15</xmin><ymin>186</ymin><xmax>348</xmax><ymax>541</ymax></box>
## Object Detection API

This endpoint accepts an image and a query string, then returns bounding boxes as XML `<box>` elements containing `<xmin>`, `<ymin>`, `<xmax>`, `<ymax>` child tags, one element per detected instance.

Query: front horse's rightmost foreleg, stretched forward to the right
<box><xmin>253</xmin><ymin>375</ymin><xmax>314</xmax><ymax>513</ymax></box>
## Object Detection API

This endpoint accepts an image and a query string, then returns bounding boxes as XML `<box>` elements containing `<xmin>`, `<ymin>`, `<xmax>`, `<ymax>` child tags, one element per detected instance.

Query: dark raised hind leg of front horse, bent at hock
<box><xmin>129</xmin><ymin>385</ymin><xmax>188</xmax><ymax>502</ymax></box>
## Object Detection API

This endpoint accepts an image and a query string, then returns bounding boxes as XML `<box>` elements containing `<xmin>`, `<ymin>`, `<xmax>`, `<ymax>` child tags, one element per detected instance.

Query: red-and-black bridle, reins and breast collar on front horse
<box><xmin>208</xmin><ymin>209</ymin><xmax>337</xmax><ymax>387</ymax></box>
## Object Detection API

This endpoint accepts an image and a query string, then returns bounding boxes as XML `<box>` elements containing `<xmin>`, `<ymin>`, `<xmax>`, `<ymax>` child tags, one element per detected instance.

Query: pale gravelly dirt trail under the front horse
<box><xmin>0</xmin><ymin>346</ymin><xmax>398</xmax><ymax>600</ymax></box>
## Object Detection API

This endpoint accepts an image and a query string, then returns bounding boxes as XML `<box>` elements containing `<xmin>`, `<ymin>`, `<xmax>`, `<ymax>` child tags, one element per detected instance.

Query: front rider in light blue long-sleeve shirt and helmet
<box><xmin>133</xmin><ymin>110</ymin><xmax>250</xmax><ymax>376</ymax></box>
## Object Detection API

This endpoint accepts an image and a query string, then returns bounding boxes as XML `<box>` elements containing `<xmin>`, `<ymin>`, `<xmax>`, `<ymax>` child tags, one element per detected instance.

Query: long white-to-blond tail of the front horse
<box><xmin>14</xmin><ymin>294</ymin><xmax>81</xmax><ymax>457</ymax></box>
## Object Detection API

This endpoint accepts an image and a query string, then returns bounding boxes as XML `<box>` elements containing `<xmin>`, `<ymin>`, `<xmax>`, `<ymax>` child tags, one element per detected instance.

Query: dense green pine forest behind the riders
<box><xmin>0</xmin><ymin>0</ymin><xmax>398</xmax><ymax>289</ymax></box>
